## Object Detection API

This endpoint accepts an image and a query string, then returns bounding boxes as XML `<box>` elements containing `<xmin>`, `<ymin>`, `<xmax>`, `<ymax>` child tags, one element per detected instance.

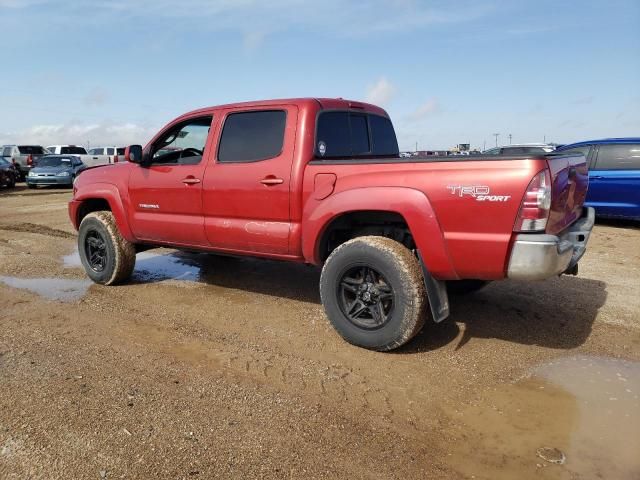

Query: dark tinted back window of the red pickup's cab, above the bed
<box><xmin>316</xmin><ymin>111</ymin><xmax>400</xmax><ymax>158</ymax></box>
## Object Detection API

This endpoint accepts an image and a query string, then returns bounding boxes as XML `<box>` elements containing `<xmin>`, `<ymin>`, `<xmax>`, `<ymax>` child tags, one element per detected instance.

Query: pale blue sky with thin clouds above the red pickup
<box><xmin>0</xmin><ymin>0</ymin><xmax>640</xmax><ymax>150</ymax></box>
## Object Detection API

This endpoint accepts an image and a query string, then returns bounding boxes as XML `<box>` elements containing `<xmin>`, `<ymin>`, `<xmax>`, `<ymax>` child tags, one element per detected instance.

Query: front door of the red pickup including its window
<box><xmin>129</xmin><ymin>116</ymin><xmax>212</xmax><ymax>246</ymax></box>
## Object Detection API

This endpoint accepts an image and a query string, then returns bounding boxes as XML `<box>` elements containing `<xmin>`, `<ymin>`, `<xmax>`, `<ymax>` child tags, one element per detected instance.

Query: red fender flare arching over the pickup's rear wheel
<box><xmin>302</xmin><ymin>187</ymin><xmax>458</xmax><ymax>280</ymax></box>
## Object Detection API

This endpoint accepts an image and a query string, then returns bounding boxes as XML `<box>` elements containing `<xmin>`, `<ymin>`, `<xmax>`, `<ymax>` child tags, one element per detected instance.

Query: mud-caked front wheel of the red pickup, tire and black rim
<box><xmin>78</xmin><ymin>211</ymin><xmax>136</xmax><ymax>285</ymax></box>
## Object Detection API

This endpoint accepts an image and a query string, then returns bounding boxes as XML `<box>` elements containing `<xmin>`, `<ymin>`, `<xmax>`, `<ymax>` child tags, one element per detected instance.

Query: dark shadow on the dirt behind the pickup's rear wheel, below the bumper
<box><xmin>401</xmin><ymin>276</ymin><xmax>607</xmax><ymax>353</ymax></box>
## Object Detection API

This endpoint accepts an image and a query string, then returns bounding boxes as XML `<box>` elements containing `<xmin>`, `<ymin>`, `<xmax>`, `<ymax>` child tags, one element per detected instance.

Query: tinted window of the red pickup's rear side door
<box><xmin>218</xmin><ymin>110</ymin><xmax>287</xmax><ymax>163</ymax></box>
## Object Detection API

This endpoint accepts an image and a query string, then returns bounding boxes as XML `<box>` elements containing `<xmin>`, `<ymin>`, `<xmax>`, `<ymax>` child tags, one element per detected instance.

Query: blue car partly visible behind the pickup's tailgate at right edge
<box><xmin>556</xmin><ymin>138</ymin><xmax>640</xmax><ymax>220</ymax></box>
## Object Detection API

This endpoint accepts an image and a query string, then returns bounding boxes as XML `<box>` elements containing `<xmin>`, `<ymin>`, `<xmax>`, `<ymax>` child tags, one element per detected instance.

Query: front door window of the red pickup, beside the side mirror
<box><xmin>150</xmin><ymin>115</ymin><xmax>213</xmax><ymax>165</ymax></box>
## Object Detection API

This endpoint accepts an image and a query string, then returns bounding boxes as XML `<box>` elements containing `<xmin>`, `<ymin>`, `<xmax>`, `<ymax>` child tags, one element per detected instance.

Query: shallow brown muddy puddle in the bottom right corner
<box><xmin>449</xmin><ymin>356</ymin><xmax>640</xmax><ymax>480</ymax></box>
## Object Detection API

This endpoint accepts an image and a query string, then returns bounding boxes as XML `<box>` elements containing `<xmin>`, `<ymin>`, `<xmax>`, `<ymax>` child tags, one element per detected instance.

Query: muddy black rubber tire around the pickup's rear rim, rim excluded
<box><xmin>320</xmin><ymin>236</ymin><xmax>428</xmax><ymax>351</ymax></box>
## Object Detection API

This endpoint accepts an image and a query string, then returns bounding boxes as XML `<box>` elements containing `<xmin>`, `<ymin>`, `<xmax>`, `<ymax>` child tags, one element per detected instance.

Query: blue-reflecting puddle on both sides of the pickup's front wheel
<box><xmin>62</xmin><ymin>250</ymin><xmax>201</xmax><ymax>282</ymax></box>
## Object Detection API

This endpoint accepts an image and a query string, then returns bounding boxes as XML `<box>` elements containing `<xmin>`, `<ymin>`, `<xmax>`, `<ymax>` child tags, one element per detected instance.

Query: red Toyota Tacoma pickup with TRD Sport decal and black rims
<box><xmin>69</xmin><ymin>98</ymin><xmax>594</xmax><ymax>350</ymax></box>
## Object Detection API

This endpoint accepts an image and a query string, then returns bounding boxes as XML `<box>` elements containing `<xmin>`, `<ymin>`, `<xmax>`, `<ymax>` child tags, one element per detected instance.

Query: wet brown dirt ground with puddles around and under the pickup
<box><xmin>0</xmin><ymin>187</ymin><xmax>640</xmax><ymax>479</ymax></box>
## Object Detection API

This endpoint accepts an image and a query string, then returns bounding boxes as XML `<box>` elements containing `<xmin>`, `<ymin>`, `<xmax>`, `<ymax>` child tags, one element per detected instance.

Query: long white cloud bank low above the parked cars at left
<box><xmin>0</xmin><ymin>122</ymin><xmax>158</xmax><ymax>147</ymax></box>
